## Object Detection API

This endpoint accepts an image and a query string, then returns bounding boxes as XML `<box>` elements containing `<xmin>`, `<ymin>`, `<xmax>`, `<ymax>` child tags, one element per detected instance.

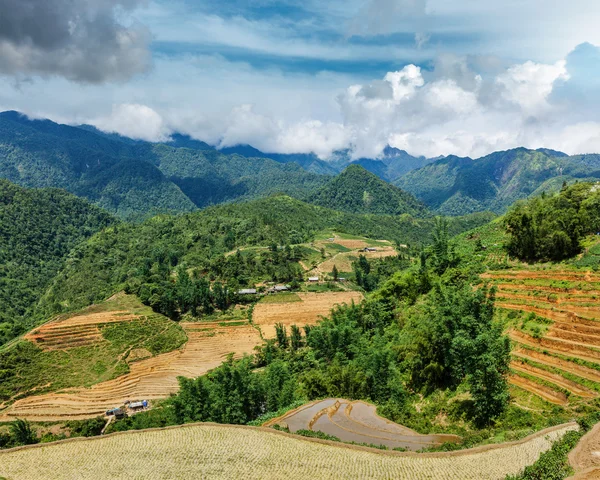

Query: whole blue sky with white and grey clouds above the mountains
<box><xmin>0</xmin><ymin>0</ymin><xmax>600</xmax><ymax>159</ymax></box>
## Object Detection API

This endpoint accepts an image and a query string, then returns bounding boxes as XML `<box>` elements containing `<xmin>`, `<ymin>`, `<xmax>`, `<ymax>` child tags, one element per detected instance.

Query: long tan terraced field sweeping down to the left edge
<box><xmin>0</xmin><ymin>322</ymin><xmax>262</xmax><ymax>421</ymax></box>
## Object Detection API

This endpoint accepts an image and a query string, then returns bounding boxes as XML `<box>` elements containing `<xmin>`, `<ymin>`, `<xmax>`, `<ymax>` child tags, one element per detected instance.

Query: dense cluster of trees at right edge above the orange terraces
<box><xmin>505</xmin><ymin>183</ymin><xmax>600</xmax><ymax>261</ymax></box>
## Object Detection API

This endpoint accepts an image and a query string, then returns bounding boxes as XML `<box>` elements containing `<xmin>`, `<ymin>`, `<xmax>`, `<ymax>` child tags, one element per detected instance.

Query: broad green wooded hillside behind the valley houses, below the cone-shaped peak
<box><xmin>35</xmin><ymin>196</ymin><xmax>491</xmax><ymax>322</ymax></box>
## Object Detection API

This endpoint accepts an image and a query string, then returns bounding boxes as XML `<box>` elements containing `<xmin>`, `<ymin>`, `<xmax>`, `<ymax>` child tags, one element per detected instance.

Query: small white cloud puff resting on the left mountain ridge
<box><xmin>90</xmin><ymin>103</ymin><xmax>171</xmax><ymax>142</ymax></box>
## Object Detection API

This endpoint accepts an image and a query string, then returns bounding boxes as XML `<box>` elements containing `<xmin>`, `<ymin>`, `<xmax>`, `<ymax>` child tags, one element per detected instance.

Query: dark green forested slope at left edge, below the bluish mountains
<box><xmin>0</xmin><ymin>180</ymin><xmax>116</xmax><ymax>345</ymax></box>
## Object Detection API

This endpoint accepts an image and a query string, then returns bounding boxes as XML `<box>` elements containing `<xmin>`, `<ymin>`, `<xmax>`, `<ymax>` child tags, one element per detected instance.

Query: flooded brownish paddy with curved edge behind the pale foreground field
<box><xmin>266</xmin><ymin>398</ymin><xmax>460</xmax><ymax>451</ymax></box>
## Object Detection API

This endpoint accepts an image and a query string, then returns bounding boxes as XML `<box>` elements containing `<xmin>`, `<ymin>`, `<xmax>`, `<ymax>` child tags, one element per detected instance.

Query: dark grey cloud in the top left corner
<box><xmin>0</xmin><ymin>0</ymin><xmax>150</xmax><ymax>83</ymax></box>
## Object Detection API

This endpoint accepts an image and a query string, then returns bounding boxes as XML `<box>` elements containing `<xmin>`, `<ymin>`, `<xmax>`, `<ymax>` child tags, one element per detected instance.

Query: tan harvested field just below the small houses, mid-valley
<box><xmin>252</xmin><ymin>292</ymin><xmax>363</xmax><ymax>338</ymax></box>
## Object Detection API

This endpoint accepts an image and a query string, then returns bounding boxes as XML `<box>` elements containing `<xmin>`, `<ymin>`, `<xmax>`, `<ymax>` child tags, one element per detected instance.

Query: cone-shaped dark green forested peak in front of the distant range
<box><xmin>312</xmin><ymin>165</ymin><xmax>427</xmax><ymax>216</ymax></box>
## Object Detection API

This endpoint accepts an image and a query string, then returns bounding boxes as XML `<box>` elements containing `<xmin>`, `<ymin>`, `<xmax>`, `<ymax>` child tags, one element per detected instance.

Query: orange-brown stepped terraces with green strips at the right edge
<box><xmin>482</xmin><ymin>270</ymin><xmax>600</xmax><ymax>406</ymax></box>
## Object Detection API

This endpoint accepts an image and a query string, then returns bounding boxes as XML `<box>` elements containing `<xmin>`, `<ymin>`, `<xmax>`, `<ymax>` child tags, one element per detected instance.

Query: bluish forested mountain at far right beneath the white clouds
<box><xmin>395</xmin><ymin>148</ymin><xmax>600</xmax><ymax>215</ymax></box>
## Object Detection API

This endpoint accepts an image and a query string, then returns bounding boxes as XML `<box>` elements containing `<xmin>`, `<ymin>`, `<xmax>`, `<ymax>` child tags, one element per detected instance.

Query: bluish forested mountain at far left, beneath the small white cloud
<box><xmin>0</xmin><ymin>112</ymin><xmax>194</xmax><ymax>218</ymax></box>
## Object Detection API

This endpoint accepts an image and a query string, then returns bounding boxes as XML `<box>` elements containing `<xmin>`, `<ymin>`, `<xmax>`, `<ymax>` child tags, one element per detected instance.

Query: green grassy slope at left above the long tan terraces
<box><xmin>0</xmin><ymin>296</ymin><xmax>187</xmax><ymax>403</ymax></box>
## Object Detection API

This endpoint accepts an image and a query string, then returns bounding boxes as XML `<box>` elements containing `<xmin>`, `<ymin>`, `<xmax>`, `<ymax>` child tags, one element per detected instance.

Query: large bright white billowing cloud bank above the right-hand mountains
<box><xmin>338</xmin><ymin>50</ymin><xmax>596</xmax><ymax>157</ymax></box>
